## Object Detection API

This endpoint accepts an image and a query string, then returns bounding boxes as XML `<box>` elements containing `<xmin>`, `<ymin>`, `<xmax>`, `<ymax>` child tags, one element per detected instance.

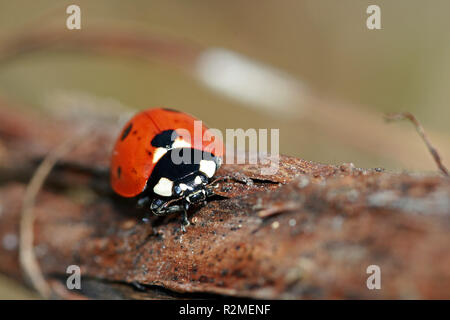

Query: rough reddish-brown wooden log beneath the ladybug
<box><xmin>0</xmin><ymin>103</ymin><xmax>450</xmax><ymax>299</ymax></box>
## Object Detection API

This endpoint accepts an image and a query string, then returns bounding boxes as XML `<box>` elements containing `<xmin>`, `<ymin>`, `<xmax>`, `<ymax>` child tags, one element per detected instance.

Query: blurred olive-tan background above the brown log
<box><xmin>0</xmin><ymin>0</ymin><xmax>450</xmax><ymax>298</ymax></box>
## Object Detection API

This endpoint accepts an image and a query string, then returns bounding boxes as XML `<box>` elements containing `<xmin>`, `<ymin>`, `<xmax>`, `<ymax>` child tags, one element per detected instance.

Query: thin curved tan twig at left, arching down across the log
<box><xmin>19</xmin><ymin>129</ymin><xmax>89</xmax><ymax>299</ymax></box>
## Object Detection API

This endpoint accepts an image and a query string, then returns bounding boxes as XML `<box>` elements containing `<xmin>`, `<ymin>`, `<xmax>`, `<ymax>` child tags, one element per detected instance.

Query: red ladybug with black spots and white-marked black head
<box><xmin>110</xmin><ymin>108</ymin><xmax>223</xmax><ymax>231</ymax></box>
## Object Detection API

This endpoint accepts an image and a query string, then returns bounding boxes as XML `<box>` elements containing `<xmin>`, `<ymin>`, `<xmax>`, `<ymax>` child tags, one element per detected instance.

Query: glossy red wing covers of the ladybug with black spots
<box><xmin>110</xmin><ymin>108</ymin><xmax>223</xmax><ymax>197</ymax></box>
